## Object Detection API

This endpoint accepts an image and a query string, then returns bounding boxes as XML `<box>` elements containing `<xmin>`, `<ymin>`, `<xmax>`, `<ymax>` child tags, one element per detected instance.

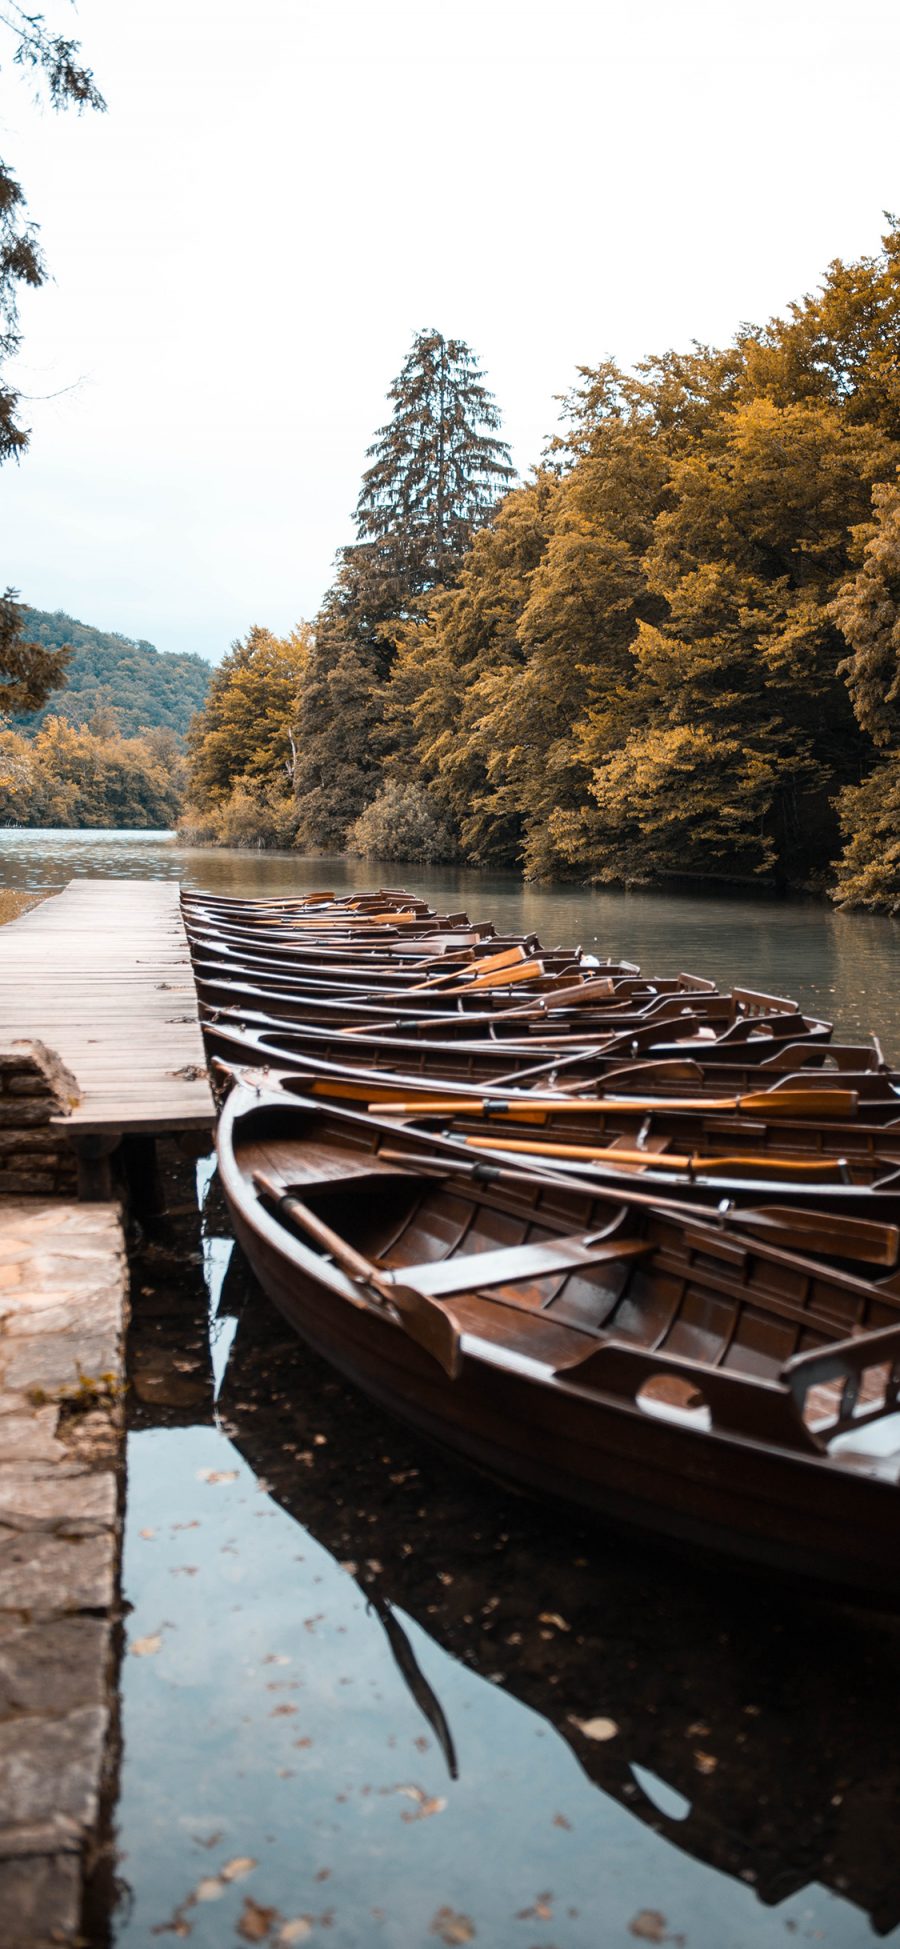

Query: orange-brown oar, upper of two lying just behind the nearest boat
<box><xmin>366</xmin><ymin>1091</ymin><xmax>859</xmax><ymax>1123</ymax></box>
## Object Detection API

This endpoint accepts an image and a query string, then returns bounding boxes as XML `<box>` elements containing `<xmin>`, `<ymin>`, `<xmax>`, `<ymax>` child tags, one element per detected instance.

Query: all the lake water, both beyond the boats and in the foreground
<box><xmin>0</xmin><ymin>832</ymin><xmax>900</xmax><ymax>1949</ymax></box>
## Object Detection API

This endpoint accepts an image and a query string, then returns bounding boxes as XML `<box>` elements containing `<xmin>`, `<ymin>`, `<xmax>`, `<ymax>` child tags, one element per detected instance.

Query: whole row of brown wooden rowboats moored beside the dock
<box><xmin>183</xmin><ymin>889</ymin><xmax>900</xmax><ymax>1604</ymax></box>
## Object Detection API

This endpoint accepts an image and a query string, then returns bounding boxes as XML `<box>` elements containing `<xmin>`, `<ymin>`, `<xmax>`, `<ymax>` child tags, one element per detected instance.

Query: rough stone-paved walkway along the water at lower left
<box><xmin>0</xmin><ymin>1199</ymin><xmax>127</xmax><ymax>1949</ymax></box>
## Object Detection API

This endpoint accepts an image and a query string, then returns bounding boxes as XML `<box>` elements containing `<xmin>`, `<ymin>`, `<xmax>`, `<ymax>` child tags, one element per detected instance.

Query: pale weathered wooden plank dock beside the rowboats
<box><xmin>0</xmin><ymin>879</ymin><xmax>214</xmax><ymax>1138</ymax></box>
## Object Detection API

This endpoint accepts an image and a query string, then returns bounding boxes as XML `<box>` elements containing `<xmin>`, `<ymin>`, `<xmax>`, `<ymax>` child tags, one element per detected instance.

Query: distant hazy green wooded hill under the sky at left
<box><xmin>14</xmin><ymin>608</ymin><xmax>212</xmax><ymax>737</ymax></box>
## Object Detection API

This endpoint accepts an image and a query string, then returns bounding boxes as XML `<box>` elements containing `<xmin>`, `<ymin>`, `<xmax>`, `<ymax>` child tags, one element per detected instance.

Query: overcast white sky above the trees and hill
<box><xmin>0</xmin><ymin>0</ymin><xmax>900</xmax><ymax>661</ymax></box>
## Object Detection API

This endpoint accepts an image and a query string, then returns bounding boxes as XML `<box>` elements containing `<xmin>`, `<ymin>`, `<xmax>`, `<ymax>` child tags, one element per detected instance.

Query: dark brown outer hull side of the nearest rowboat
<box><xmin>226</xmin><ymin>1185</ymin><xmax>900</xmax><ymax>1610</ymax></box>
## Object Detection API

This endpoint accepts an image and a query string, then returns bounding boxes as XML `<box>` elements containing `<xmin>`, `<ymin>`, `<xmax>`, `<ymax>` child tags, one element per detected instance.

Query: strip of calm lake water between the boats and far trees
<box><xmin>0</xmin><ymin>830</ymin><xmax>900</xmax><ymax>1062</ymax></box>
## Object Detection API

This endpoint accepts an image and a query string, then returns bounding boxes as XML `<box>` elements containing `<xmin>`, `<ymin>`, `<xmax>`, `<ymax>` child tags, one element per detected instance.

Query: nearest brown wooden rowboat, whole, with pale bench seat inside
<box><xmin>218</xmin><ymin>1088</ymin><xmax>900</xmax><ymax>1604</ymax></box>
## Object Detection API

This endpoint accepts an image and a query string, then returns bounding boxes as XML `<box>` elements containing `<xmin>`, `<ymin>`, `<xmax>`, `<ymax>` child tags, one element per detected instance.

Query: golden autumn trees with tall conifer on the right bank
<box><xmin>185</xmin><ymin>231</ymin><xmax>900</xmax><ymax>912</ymax></box>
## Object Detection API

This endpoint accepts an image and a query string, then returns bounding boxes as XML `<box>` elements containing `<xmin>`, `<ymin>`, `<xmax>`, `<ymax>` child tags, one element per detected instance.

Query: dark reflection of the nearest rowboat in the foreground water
<box><xmin>218</xmin><ymin>1253</ymin><xmax>900</xmax><ymax>1935</ymax></box>
